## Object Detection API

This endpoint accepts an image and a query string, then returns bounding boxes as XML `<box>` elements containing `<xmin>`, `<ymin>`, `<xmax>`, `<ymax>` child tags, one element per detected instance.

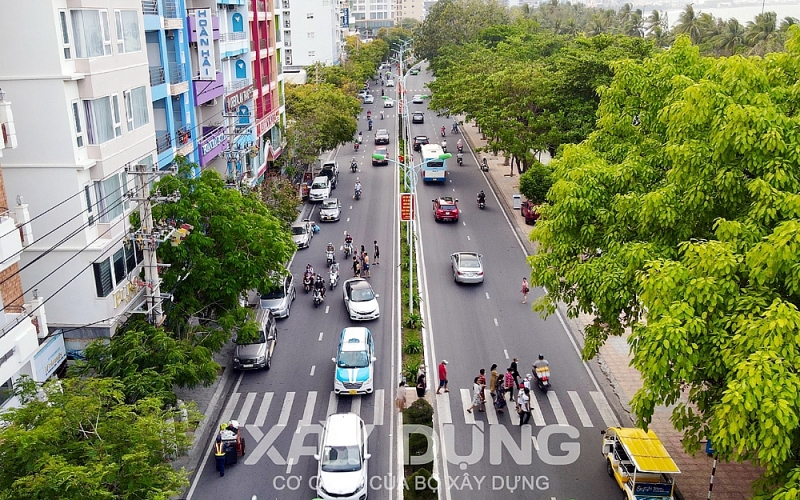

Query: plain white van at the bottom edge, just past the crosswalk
<box><xmin>314</xmin><ymin>413</ymin><xmax>370</xmax><ymax>500</ymax></box>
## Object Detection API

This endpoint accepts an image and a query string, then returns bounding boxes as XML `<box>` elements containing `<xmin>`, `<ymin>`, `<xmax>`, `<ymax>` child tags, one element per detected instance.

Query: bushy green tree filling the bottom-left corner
<box><xmin>0</xmin><ymin>378</ymin><xmax>199</xmax><ymax>500</ymax></box>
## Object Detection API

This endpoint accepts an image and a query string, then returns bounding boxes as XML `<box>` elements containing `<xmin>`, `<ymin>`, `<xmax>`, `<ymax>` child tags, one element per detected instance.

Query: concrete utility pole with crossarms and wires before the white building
<box><xmin>126</xmin><ymin>164</ymin><xmax>180</xmax><ymax>326</ymax></box>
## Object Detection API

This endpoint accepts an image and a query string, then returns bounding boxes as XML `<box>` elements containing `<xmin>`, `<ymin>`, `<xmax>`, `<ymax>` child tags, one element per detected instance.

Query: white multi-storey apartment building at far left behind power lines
<box><xmin>0</xmin><ymin>0</ymin><xmax>158</xmax><ymax>351</ymax></box>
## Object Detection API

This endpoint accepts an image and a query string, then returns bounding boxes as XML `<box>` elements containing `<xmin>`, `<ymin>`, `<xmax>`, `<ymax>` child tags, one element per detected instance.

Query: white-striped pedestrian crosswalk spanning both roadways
<box><xmin>220</xmin><ymin>389</ymin><xmax>619</xmax><ymax>428</ymax></box>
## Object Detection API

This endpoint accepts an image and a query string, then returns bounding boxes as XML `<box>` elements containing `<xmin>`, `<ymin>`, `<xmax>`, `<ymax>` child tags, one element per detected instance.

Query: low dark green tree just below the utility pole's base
<box><xmin>74</xmin><ymin>320</ymin><xmax>220</xmax><ymax>404</ymax></box>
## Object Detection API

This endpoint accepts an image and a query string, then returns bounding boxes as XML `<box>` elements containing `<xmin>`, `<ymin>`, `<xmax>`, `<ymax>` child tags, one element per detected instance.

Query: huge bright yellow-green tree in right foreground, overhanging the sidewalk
<box><xmin>530</xmin><ymin>29</ymin><xmax>800</xmax><ymax>499</ymax></box>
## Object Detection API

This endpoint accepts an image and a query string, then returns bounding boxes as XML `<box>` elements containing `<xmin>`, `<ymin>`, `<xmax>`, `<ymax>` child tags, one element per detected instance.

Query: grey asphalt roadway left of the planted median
<box><xmin>191</xmin><ymin>75</ymin><xmax>400</xmax><ymax>500</ymax></box>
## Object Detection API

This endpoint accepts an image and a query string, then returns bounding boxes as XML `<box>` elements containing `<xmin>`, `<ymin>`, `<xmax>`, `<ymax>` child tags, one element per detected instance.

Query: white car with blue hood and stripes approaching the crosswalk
<box><xmin>331</xmin><ymin>327</ymin><xmax>376</xmax><ymax>395</ymax></box>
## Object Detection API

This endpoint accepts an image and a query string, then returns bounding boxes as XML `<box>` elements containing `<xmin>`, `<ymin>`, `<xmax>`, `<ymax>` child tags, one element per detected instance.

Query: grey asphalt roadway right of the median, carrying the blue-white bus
<box><xmin>407</xmin><ymin>63</ymin><xmax>621</xmax><ymax>500</ymax></box>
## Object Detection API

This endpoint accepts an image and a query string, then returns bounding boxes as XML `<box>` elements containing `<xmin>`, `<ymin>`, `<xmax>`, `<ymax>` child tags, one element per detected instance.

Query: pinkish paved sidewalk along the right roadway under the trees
<box><xmin>461</xmin><ymin>119</ymin><xmax>759</xmax><ymax>500</ymax></box>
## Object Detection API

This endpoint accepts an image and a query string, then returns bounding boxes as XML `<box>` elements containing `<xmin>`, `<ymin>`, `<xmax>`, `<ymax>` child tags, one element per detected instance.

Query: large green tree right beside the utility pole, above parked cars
<box><xmin>153</xmin><ymin>163</ymin><xmax>295</xmax><ymax>338</ymax></box>
